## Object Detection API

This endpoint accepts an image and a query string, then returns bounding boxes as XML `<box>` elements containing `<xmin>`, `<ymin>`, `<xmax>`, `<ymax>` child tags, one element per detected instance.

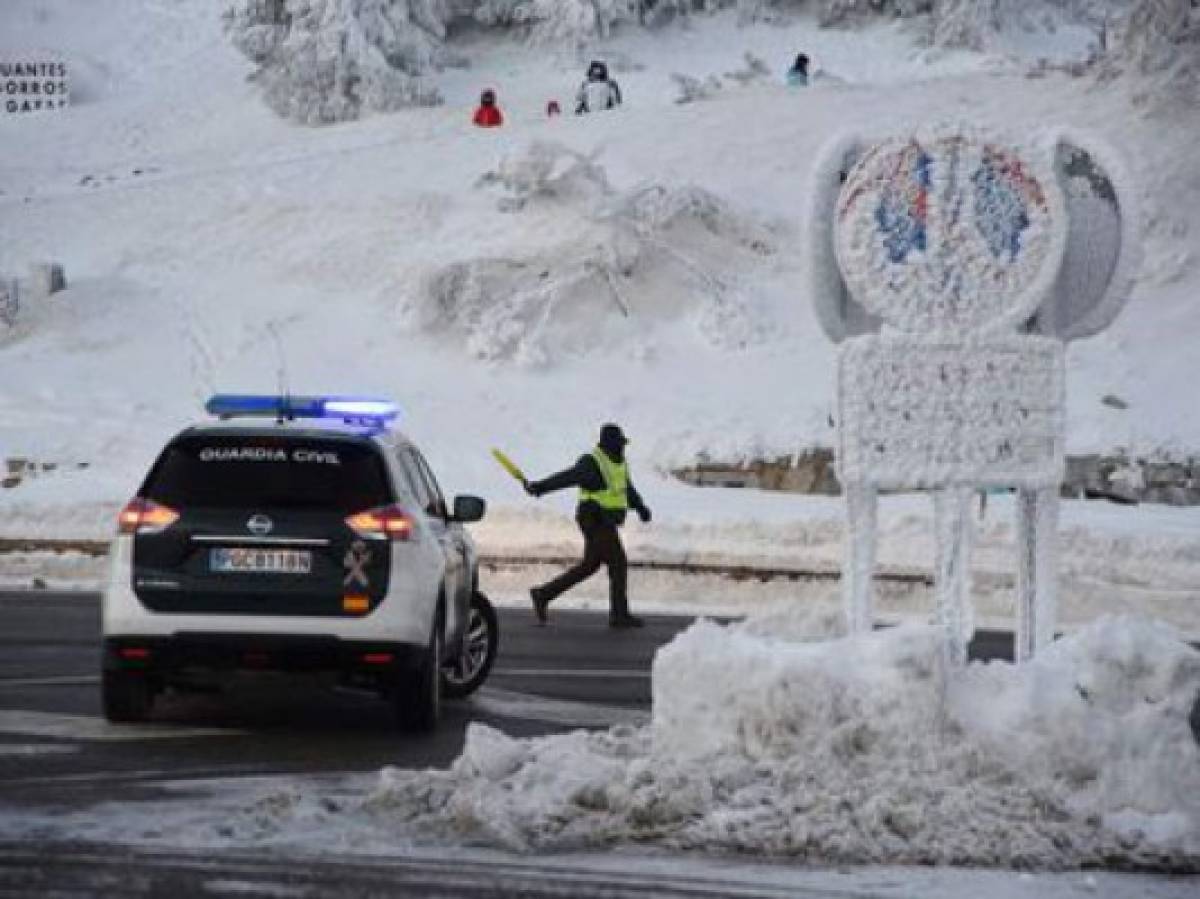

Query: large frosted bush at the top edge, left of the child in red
<box><xmin>224</xmin><ymin>0</ymin><xmax>451</xmax><ymax>125</ymax></box>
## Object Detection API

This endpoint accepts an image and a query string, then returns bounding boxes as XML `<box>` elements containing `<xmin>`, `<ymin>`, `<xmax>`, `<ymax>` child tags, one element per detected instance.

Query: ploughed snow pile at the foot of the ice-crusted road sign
<box><xmin>338</xmin><ymin>613</ymin><xmax>1200</xmax><ymax>870</ymax></box>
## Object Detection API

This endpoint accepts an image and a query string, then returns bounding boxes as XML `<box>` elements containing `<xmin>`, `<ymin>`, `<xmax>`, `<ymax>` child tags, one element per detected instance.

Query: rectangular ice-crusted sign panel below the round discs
<box><xmin>839</xmin><ymin>335</ymin><xmax>1063</xmax><ymax>490</ymax></box>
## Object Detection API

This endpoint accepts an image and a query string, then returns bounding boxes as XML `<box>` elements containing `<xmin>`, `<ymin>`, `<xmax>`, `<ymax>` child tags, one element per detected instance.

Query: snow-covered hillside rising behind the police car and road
<box><xmin>0</xmin><ymin>0</ymin><xmax>1200</xmax><ymax>533</ymax></box>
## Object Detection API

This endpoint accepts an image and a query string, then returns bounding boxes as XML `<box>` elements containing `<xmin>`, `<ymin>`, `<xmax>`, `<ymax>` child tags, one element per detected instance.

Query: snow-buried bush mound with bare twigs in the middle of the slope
<box><xmin>400</xmin><ymin>143</ymin><xmax>774</xmax><ymax>365</ymax></box>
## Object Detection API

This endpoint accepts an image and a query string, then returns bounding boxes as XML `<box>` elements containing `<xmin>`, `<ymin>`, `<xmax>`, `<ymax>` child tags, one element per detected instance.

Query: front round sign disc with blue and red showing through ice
<box><xmin>835</xmin><ymin>134</ymin><xmax>1063</xmax><ymax>335</ymax></box>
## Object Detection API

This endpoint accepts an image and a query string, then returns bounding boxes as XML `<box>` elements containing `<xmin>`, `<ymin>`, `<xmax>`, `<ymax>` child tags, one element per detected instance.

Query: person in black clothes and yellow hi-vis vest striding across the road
<box><xmin>524</xmin><ymin>425</ymin><xmax>650</xmax><ymax>628</ymax></box>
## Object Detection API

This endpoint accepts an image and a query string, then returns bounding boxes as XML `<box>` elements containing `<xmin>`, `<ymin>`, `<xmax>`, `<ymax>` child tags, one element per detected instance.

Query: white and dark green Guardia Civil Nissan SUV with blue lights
<box><xmin>102</xmin><ymin>395</ymin><xmax>499</xmax><ymax>730</ymax></box>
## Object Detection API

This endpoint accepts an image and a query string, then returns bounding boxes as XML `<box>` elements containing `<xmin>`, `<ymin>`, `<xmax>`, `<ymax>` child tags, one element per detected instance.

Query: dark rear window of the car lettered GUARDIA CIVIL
<box><xmin>142</xmin><ymin>434</ymin><xmax>391</xmax><ymax>513</ymax></box>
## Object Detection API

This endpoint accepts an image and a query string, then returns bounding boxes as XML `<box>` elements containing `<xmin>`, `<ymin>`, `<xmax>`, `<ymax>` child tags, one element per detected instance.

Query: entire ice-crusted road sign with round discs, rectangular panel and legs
<box><xmin>811</xmin><ymin>128</ymin><xmax>1136</xmax><ymax>664</ymax></box>
